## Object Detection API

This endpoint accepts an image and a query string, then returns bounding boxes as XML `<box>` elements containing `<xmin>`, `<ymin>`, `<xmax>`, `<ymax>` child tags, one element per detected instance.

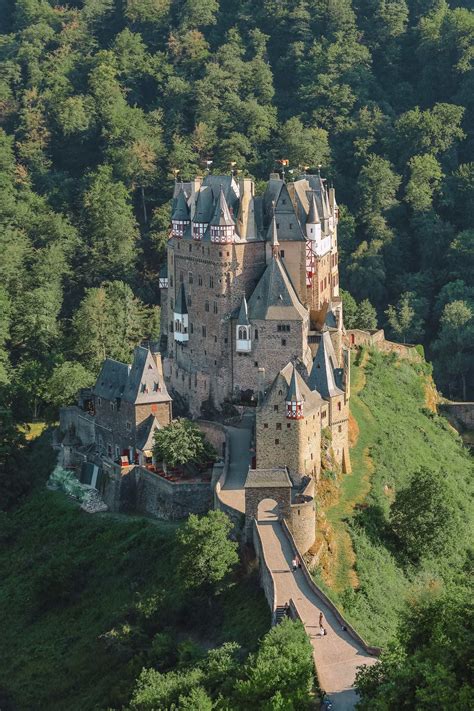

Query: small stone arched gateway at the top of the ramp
<box><xmin>245</xmin><ymin>467</ymin><xmax>292</xmax><ymax>536</ymax></box>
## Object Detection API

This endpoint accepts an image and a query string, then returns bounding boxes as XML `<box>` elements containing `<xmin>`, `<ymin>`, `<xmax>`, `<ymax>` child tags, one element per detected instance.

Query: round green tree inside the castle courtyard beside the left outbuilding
<box><xmin>153</xmin><ymin>419</ymin><xmax>216</xmax><ymax>467</ymax></box>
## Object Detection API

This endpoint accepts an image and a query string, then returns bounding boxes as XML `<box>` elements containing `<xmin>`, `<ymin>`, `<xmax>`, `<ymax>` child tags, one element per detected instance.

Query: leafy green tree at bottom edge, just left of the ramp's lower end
<box><xmin>236</xmin><ymin>619</ymin><xmax>314</xmax><ymax>711</ymax></box>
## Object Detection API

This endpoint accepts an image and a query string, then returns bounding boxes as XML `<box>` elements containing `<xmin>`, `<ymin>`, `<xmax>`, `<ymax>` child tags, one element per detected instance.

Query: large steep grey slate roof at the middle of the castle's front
<box><xmin>248</xmin><ymin>255</ymin><xmax>308</xmax><ymax>321</ymax></box>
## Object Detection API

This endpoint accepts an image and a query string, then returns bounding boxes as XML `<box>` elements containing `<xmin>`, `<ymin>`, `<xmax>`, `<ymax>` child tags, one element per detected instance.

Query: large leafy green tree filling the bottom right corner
<box><xmin>356</xmin><ymin>587</ymin><xmax>474</xmax><ymax>711</ymax></box>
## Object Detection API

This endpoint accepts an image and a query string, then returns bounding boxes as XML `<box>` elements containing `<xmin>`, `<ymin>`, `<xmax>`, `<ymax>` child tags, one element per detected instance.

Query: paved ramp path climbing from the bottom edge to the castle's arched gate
<box><xmin>258</xmin><ymin>500</ymin><xmax>377</xmax><ymax>711</ymax></box>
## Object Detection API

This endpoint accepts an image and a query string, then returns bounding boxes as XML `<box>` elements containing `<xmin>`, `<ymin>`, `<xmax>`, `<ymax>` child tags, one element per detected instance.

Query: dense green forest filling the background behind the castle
<box><xmin>0</xmin><ymin>0</ymin><xmax>474</xmax><ymax>434</ymax></box>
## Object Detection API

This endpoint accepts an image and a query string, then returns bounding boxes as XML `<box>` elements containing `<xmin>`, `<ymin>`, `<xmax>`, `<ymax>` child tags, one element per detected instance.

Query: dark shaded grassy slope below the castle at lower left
<box><xmin>0</xmin><ymin>436</ymin><xmax>270</xmax><ymax>711</ymax></box>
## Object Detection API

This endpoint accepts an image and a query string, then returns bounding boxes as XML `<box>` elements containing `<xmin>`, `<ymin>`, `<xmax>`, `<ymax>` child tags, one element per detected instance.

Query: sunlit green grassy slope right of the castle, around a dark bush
<box><xmin>316</xmin><ymin>353</ymin><xmax>472</xmax><ymax>645</ymax></box>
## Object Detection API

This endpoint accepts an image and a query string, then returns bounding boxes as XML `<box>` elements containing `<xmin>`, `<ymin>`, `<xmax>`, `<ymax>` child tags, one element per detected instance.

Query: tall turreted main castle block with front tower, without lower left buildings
<box><xmin>160</xmin><ymin>174</ymin><xmax>350</xmax><ymax>482</ymax></box>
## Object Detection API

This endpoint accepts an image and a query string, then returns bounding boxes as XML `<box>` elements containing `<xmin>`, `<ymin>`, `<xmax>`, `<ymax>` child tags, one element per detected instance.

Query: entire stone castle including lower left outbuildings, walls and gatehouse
<box><xmin>60</xmin><ymin>174</ymin><xmax>350</xmax><ymax>552</ymax></box>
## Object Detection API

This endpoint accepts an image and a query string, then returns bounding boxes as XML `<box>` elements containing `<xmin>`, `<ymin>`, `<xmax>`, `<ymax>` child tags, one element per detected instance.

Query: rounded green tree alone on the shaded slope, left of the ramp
<box><xmin>177</xmin><ymin>510</ymin><xmax>239</xmax><ymax>601</ymax></box>
